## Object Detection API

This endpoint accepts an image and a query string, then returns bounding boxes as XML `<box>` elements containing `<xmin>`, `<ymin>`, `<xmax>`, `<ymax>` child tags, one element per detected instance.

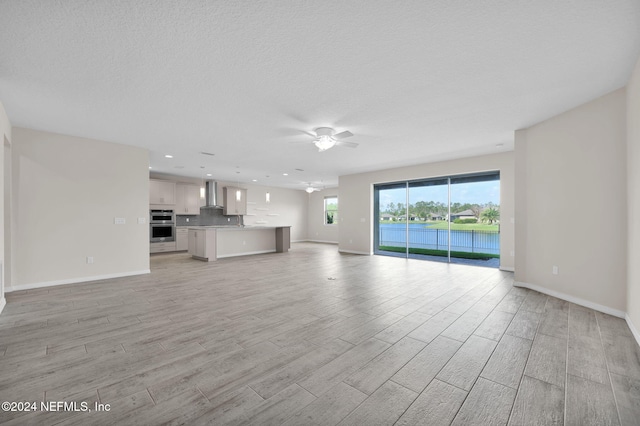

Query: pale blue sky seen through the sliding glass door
<box><xmin>380</xmin><ymin>180</ymin><xmax>500</xmax><ymax>207</ymax></box>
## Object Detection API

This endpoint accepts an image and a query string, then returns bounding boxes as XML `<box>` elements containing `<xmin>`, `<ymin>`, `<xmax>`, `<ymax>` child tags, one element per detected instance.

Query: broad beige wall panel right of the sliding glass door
<box><xmin>515</xmin><ymin>89</ymin><xmax>627</xmax><ymax>315</ymax></box>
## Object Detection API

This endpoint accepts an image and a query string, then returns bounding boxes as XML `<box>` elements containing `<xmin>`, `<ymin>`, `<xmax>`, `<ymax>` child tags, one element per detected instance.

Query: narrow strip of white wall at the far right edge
<box><xmin>627</xmin><ymin>60</ymin><xmax>640</xmax><ymax>336</ymax></box>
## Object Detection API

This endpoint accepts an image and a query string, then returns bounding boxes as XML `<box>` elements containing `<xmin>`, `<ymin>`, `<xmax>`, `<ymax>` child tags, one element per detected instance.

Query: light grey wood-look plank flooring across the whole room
<box><xmin>0</xmin><ymin>243</ymin><xmax>640</xmax><ymax>425</ymax></box>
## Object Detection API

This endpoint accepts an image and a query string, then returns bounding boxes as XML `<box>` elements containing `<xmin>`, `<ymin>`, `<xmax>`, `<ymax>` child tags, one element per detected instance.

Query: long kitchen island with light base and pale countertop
<box><xmin>188</xmin><ymin>226</ymin><xmax>291</xmax><ymax>262</ymax></box>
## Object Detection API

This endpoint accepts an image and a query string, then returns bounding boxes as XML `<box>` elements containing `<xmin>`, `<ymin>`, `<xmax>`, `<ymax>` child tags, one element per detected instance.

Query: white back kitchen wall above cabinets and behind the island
<box><xmin>150</xmin><ymin>173</ymin><xmax>309</xmax><ymax>241</ymax></box>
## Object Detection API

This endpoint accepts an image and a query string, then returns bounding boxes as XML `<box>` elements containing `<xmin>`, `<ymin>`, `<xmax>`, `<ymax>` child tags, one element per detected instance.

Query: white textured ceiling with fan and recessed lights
<box><xmin>0</xmin><ymin>0</ymin><xmax>640</xmax><ymax>189</ymax></box>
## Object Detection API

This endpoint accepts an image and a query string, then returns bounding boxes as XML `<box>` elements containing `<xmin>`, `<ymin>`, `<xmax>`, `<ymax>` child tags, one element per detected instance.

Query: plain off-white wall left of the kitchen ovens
<box><xmin>11</xmin><ymin>128</ymin><xmax>149</xmax><ymax>291</ymax></box>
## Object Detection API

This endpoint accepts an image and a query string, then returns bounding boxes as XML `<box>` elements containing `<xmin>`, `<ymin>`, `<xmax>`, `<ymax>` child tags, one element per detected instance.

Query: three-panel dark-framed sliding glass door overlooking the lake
<box><xmin>374</xmin><ymin>172</ymin><xmax>500</xmax><ymax>267</ymax></box>
